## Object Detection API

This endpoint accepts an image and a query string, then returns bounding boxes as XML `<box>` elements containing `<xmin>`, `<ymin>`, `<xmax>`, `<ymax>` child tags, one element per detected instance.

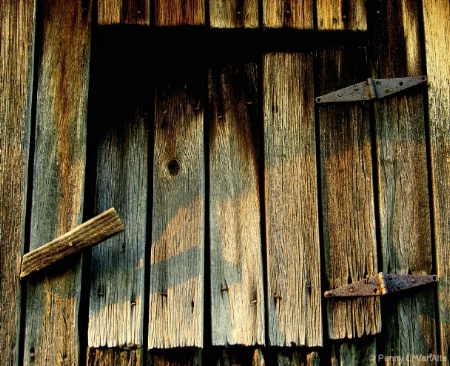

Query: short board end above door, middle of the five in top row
<box><xmin>209</xmin><ymin>0</ymin><xmax>259</xmax><ymax>28</ymax></box>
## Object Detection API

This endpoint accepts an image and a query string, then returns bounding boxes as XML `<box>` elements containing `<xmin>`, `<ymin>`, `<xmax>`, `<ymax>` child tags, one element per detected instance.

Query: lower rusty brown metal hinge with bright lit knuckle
<box><xmin>324</xmin><ymin>272</ymin><xmax>437</xmax><ymax>298</ymax></box>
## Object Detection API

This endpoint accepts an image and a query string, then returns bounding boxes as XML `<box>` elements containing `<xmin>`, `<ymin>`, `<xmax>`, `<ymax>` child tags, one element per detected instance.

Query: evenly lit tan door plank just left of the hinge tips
<box><xmin>263</xmin><ymin>53</ymin><xmax>322</xmax><ymax>346</ymax></box>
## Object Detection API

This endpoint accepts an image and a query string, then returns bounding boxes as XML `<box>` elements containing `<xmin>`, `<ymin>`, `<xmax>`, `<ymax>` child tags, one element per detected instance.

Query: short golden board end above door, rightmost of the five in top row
<box><xmin>316</xmin><ymin>0</ymin><xmax>367</xmax><ymax>31</ymax></box>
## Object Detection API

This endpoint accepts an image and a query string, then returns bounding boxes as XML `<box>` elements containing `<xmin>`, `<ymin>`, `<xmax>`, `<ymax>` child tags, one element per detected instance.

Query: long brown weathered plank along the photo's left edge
<box><xmin>0</xmin><ymin>0</ymin><xmax>35</xmax><ymax>365</ymax></box>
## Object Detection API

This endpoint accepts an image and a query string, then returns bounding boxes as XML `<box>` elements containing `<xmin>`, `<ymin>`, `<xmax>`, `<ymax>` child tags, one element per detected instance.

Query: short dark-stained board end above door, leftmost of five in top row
<box><xmin>97</xmin><ymin>0</ymin><xmax>150</xmax><ymax>25</ymax></box>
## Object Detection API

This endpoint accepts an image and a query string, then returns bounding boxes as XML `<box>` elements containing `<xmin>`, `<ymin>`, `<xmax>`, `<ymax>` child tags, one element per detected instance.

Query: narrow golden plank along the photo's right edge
<box><xmin>423</xmin><ymin>0</ymin><xmax>450</xmax><ymax>360</ymax></box>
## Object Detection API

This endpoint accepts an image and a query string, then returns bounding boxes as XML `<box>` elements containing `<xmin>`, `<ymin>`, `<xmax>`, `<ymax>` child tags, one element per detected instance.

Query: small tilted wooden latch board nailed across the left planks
<box><xmin>20</xmin><ymin>208</ymin><xmax>125</xmax><ymax>278</ymax></box>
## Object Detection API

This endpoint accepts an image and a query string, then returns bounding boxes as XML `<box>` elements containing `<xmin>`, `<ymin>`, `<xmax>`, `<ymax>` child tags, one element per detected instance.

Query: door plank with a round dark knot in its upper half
<box><xmin>148</xmin><ymin>58</ymin><xmax>206</xmax><ymax>348</ymax></box>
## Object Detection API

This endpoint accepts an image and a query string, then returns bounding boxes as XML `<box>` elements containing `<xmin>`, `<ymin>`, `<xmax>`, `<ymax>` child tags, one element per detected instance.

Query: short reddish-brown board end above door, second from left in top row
<box><xmin>154</xmin><ymin>0</ymin><xmax>205</xmax><ymax>27</ymax></box>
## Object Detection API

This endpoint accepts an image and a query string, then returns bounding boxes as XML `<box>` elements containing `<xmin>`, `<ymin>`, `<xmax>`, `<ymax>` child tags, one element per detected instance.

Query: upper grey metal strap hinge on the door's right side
<box><xmin>316</xmin><ymin>75</ymin><xmax>427</xmax><ymax>103</ymax></box>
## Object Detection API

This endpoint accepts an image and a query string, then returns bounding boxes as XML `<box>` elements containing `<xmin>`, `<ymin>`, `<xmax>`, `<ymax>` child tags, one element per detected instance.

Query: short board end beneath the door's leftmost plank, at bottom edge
<box><xmin>87</xmin><ymin>348</ymin><xmax>144</xmax><ymax>366</ymax></box>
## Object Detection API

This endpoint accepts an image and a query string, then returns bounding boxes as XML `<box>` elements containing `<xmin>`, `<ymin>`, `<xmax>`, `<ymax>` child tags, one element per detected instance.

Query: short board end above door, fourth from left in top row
<box><xmin>262</xmin><ymin>0</ymin><xmax>314</xmax><ymax>29</ymax></box>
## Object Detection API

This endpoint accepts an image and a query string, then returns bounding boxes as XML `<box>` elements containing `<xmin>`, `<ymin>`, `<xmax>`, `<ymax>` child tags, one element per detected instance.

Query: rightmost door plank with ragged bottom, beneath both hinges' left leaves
<box><xmin>316</xmin><ymin>47</ymin><xmax>381</xmax><ymax>339</ymax></box>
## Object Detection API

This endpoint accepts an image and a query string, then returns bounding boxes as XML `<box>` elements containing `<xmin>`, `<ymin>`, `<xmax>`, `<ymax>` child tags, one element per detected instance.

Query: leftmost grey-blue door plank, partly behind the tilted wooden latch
<box><xmin>88</xmin><ymin>36</ymin><xmax>151</xmax><ymax>357</ymax></box>
